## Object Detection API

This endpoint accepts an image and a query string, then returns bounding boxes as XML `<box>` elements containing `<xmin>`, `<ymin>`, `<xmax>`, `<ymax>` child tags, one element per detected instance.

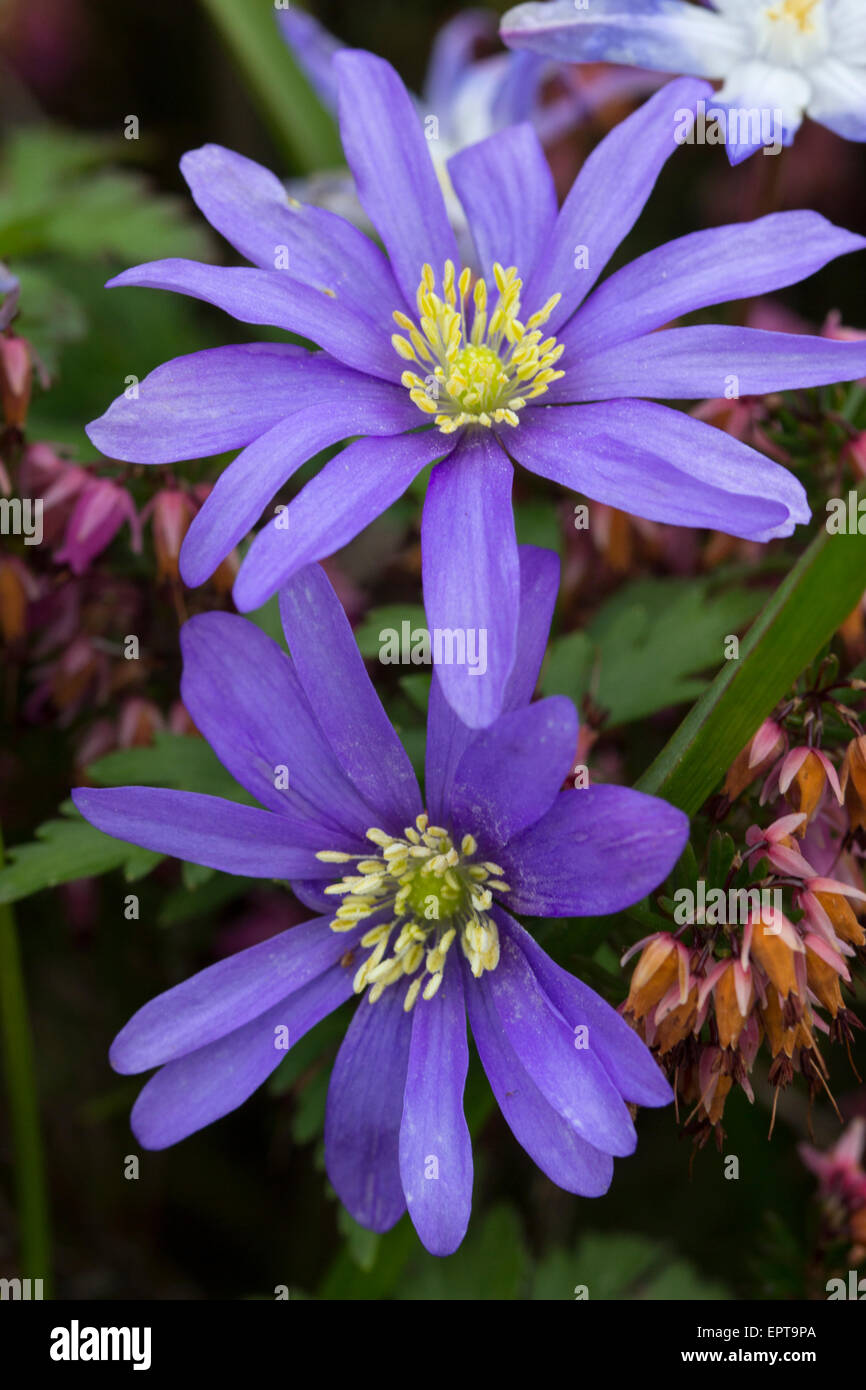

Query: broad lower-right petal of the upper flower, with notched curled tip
<box><xmin>513</xmin><ymin>397</ymin><xmax>810</xmax><ymax>541</ymax></box>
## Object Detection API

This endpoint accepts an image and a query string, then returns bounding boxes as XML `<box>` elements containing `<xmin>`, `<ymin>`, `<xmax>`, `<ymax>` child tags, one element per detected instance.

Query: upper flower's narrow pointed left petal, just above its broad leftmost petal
<box><xmin>106</xmin><ymin>259</ymin><xmax>403</xmax><ymax>382</ymax></box>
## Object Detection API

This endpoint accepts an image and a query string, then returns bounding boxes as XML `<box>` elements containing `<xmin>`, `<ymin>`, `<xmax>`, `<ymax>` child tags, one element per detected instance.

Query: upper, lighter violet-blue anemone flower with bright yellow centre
<box><xmin>88</xmin><ymin>50</ymin><xmax>866</xmax><ymax>727</ymax></box>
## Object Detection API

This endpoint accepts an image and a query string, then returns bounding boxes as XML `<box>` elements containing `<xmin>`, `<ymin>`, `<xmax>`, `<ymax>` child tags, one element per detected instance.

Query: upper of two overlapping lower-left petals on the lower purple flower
<box><xmin>110</xmin><ymin>917</ymin><xmax>363</xmax><ymax>1076</ymax></box>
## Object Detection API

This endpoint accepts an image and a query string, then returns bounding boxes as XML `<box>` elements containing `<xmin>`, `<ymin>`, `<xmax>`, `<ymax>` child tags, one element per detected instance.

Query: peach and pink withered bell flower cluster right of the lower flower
<box><xmin>623</xmin><ymin>706</ymin><xmax>866</xmax><ymax>1145</ymax></box>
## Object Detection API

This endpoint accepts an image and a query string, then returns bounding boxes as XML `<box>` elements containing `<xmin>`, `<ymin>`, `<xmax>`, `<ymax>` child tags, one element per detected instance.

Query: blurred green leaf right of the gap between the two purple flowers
<box><xmin>541</xmin><ymin>580</ymin><xmax>760</xmax><ymax>726</ymax></box>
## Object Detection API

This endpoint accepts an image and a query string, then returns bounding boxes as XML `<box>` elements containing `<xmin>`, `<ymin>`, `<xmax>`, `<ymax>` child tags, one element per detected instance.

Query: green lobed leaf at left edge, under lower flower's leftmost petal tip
<box><xmin>0</xmin><ymin>802</ymin><xmax>163</xmax><ymax>902</ymax></box>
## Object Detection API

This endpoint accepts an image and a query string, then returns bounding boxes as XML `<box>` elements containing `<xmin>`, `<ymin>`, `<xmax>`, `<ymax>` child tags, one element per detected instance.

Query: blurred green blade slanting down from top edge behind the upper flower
<box><xmin>202</xmin><ymin>0</ymin><xmax>343</xmax><ymax>172</ymax></box>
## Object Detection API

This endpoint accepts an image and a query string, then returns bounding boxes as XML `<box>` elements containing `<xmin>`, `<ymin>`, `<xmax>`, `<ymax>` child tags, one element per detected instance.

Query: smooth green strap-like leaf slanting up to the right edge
<box><xmin>638</xmin><ymin>511</ymin><xmax>866</xmax><ymax>815</ymax></box>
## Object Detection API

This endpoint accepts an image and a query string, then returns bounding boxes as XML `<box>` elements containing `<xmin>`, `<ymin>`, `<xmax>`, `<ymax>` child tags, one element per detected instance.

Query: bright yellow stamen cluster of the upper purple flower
<box><xmin>391</xmin><ymin>260</ymin><xmax>564</xmax><ymax>434</ymax></box>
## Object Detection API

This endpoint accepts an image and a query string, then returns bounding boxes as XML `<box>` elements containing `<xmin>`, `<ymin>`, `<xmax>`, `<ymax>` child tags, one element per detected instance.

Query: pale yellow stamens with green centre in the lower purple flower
<box><xmin>317</xmin><ymin>812</ymin><xmax>509</xmax><ymax>1012</ymax></box>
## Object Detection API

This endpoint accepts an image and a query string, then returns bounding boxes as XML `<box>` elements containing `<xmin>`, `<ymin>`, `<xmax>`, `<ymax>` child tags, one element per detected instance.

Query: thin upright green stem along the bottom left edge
<box><xmin>0</xmin><ymin>834</ymin><xmax>51</xmax><ymax>1298</ymax></box>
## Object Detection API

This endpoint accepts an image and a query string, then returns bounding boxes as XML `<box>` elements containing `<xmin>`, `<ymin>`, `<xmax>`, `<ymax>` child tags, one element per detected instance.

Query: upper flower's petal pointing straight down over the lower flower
<box><xmin>421</xmin><ymin>430</ymin><xmax>520</xmax><ymax>728</ymax></box>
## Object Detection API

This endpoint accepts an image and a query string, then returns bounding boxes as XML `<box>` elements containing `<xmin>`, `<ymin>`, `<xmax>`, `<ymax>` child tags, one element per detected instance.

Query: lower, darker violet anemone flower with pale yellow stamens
<box><xmin>74</xmin><ymin>546</ymin><xmax>688</xmax><ymax>1255</ymax></box>
